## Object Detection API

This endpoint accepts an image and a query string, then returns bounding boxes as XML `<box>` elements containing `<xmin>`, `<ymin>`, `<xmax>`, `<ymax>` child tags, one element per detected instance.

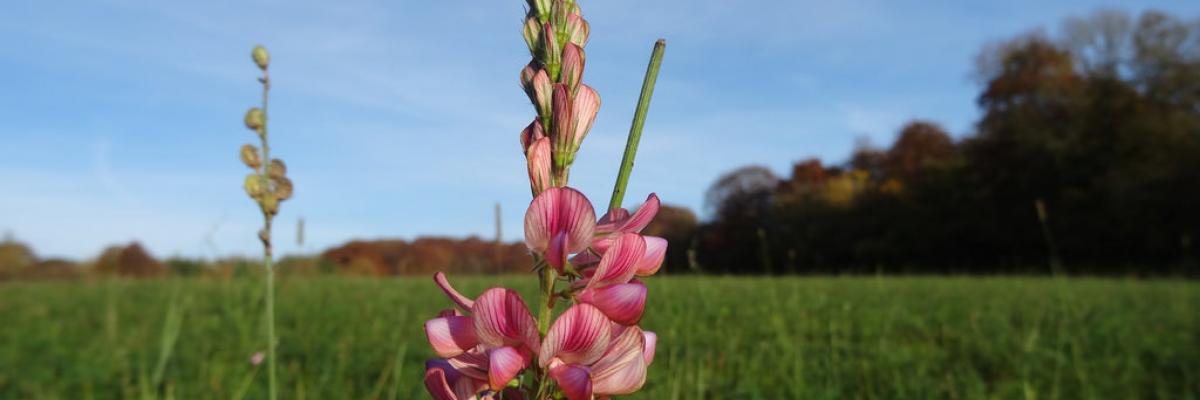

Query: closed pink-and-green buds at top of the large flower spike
<box><xmin>521</xmin><ymin>0</ymin><xmax>600</xmax><ymax>195</ymax></box>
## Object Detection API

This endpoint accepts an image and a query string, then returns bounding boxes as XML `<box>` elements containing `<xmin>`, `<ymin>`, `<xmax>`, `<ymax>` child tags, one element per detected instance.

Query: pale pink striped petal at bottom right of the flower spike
<box><xmin>592</xmin><ymin>327</ymin><xmax>646</xmax><ymax>395</ymax></box>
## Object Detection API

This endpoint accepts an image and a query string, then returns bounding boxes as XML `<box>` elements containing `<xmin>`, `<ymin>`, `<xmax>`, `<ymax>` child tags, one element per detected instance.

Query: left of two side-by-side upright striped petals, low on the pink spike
<box><xmin>470</xmin><ymin>287</ymin><xmax>539</xmax><ymax>351</ymax></box>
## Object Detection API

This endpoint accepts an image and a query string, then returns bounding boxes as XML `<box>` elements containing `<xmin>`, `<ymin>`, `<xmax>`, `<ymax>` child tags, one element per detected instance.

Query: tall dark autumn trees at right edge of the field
<box><xmin>668</xmin><ymin>11</ymin><xmax>1200</xmax><ymax>274</ymax></box>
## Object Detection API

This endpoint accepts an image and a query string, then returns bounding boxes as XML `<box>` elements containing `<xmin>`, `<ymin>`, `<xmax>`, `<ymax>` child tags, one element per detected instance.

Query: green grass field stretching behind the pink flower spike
<box><xmin>0</xmin><ymin>276</ymin><xmax>1200</xmax><ymax>399</ymax></box>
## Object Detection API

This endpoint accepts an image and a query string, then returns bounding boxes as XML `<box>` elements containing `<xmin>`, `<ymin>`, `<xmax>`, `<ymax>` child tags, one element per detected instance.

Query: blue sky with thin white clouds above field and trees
<box><xmin>0</xmin><ymin>0</ymin><xmax>1200</xmax><ymax>258</ymax></box>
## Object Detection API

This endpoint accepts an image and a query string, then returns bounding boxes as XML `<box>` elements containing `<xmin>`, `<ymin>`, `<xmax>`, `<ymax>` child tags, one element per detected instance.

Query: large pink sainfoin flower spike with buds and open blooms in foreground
<box><xmin>425</xmin><ymin>0</ymin><xmax>667</xmax><ymax>400</ymax></box>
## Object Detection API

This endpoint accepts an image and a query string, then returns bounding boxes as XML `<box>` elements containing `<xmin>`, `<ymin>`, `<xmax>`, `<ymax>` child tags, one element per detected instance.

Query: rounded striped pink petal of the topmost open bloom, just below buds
<box><xmin>524</xmin><ymin>187</ymin><xmax>596</xmax><ymax>253</ymax></box>
